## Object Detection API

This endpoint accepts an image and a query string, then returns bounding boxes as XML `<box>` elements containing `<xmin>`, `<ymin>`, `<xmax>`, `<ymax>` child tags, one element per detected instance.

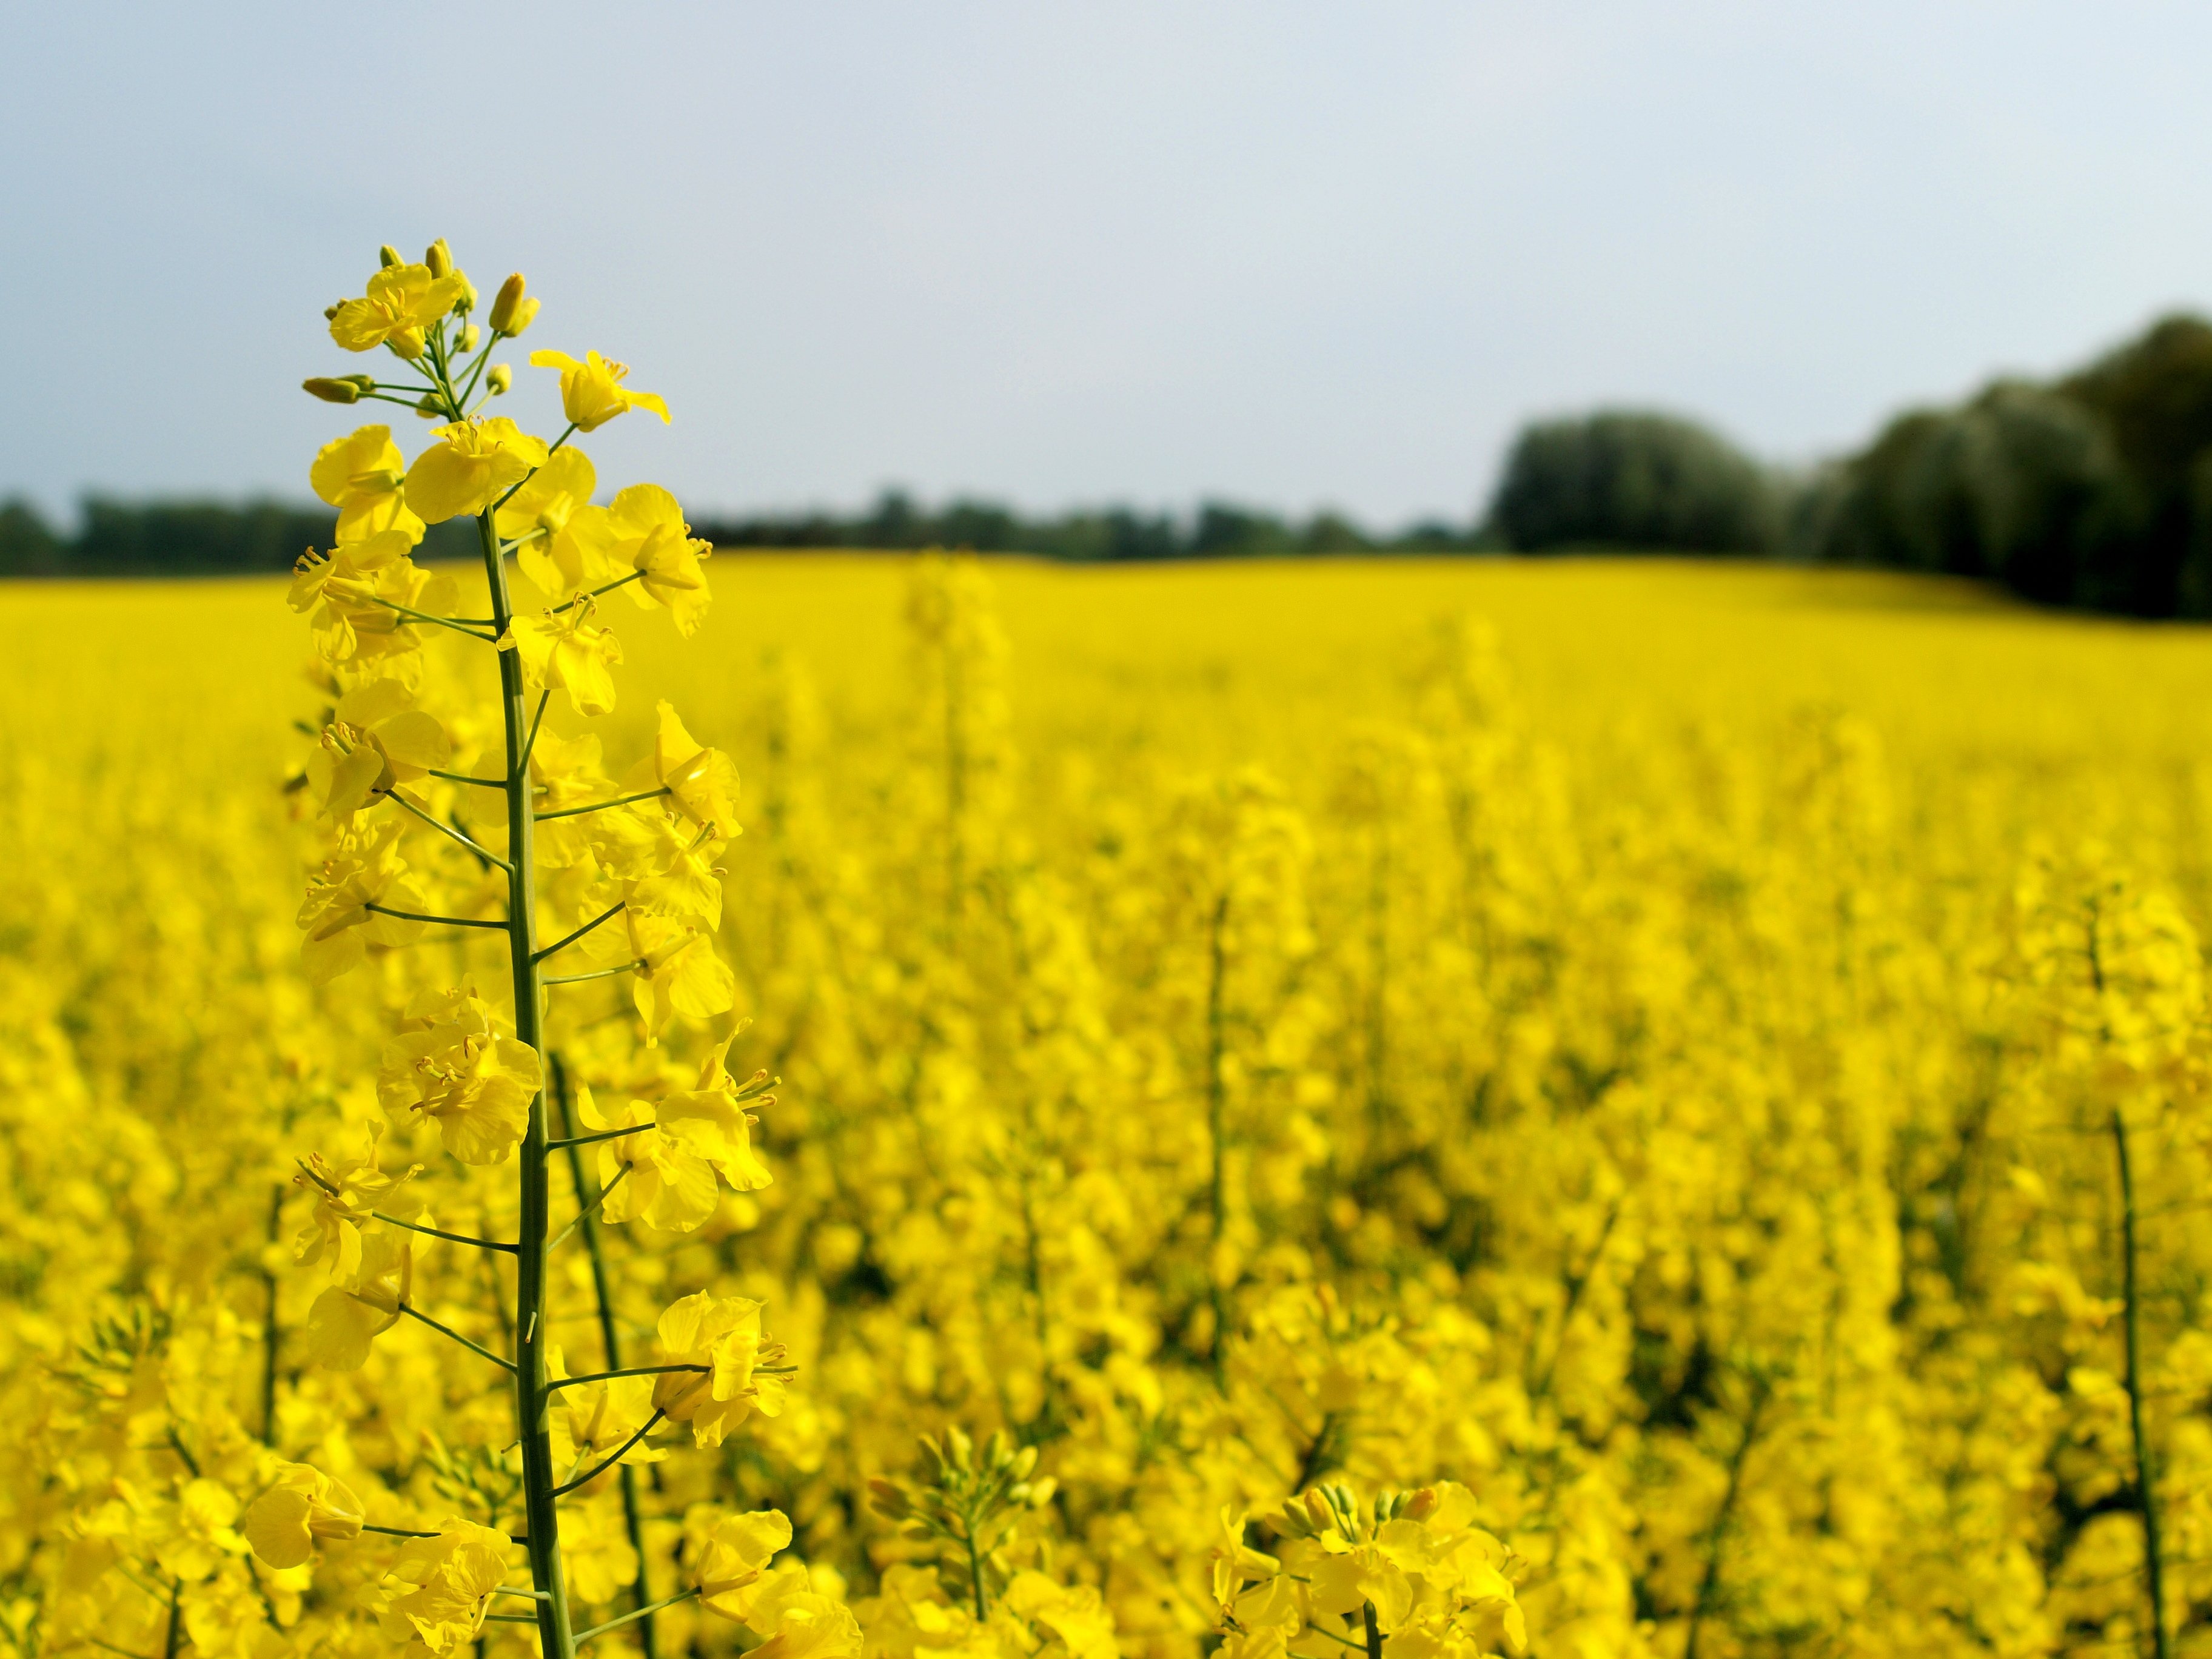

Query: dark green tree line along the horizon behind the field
<box><xmin>13</xmin><ymin>314</ymin><xmax>2212</xmax><ymax>617</ymax></box>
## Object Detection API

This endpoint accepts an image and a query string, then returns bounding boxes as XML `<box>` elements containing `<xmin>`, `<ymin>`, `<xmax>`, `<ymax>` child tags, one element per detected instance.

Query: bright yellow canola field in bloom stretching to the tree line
<box><xmin>13</xmin><ymin>555</ymin><xmax>2212</xmax><ymax>1659</ymax></box>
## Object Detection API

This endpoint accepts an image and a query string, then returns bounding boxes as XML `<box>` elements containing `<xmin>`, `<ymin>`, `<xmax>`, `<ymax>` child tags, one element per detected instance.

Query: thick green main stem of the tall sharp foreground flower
<box><xmin>475</xmin><ymin>491</ymin><xmax>575</xmax><ymax>1659</ymax></box>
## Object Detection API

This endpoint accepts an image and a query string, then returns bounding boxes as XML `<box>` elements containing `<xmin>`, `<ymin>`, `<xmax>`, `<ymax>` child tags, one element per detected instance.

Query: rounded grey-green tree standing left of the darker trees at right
<box><xmin>1489</xmin><ymin>412</ymin><xmax>1783</xmax><ymax>553</ymax></box>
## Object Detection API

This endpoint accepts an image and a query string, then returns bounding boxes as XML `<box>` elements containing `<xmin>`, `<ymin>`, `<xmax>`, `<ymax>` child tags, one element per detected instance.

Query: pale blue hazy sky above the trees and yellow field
<box><xmin>0</xmin><ymin>0</ymin><xmax>2212</xmax><ymax>525</ymax></box>
